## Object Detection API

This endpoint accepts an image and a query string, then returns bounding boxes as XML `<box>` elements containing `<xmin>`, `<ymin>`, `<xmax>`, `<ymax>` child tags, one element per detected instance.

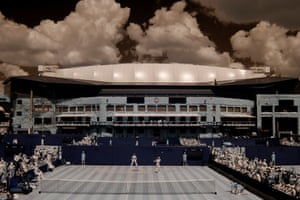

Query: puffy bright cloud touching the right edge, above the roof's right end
<box><xmin>231</xmin><ymin>21</ymin><xmax>300</xmax><ymax>77</ymax></box>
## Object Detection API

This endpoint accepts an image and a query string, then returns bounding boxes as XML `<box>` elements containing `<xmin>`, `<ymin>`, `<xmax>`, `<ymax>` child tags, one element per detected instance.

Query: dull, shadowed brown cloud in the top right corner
<box><xmin>192</xmin><ymin>0</ymin><xmax>300</xmax><ymax>29</ymax></box>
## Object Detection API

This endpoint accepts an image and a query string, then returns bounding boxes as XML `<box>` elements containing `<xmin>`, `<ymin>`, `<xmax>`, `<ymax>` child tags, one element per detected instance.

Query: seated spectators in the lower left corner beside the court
<box><xmin>0</xmin><ymin>147</ymin><xmax>60</xmax><ymax>199</ymax></box>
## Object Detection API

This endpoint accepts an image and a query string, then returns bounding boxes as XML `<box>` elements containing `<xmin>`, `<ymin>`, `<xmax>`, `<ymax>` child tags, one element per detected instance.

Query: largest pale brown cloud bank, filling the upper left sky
<box><xmin>0</xmin><ymin>0</ymin><xmax>129</xmax><ymax>66</ymax></box>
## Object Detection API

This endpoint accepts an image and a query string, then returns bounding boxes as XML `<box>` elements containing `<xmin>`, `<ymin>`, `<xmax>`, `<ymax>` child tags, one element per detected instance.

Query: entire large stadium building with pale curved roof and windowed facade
<box><xmin>5</xmin><ymin>64</ymin><xmax>299</xmax><ymax>138</ymax></box>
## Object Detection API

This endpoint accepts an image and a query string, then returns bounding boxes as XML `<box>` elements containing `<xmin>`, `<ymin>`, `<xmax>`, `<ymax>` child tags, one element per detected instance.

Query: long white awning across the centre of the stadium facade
<box><xmin>113</xmin><ymin>113</ymin><xmax>200</xmax><ymax>117</ymax></box>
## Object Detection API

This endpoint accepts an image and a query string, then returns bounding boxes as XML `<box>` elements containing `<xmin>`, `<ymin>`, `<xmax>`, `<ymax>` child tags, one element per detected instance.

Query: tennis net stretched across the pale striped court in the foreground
<box><xmin>40</xmin><ymin>179</ymin><xmax>216</xmax><ymax>194</ymax></box>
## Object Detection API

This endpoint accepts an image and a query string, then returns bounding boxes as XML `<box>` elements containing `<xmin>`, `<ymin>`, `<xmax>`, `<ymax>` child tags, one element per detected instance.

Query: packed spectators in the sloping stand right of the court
<box><xmin>212</xmin><ymin>147</ymin><xmax>300</xmax><ymax>199</ymax></box>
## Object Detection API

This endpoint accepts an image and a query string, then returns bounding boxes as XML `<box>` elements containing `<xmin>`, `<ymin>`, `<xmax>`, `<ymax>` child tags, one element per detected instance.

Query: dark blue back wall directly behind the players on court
<box><xmin>63</xmin><ymin>145</ymin><xmax>209</xmax><ymax>165</ymax></box>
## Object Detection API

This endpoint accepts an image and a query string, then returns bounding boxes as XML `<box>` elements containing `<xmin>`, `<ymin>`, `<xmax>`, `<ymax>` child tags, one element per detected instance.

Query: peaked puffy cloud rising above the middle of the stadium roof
<box><xmin>127</xmin><ymin>1</ymin><xmax>231</xmax><ymax>66</ymax></box>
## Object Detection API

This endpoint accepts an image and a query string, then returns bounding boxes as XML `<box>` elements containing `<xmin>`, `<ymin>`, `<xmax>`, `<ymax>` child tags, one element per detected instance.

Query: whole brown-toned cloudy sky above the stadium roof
<box><xmin>0</xmin><ymin>0</ymin><xmax>300</xmax><ymax>83</ymax></box>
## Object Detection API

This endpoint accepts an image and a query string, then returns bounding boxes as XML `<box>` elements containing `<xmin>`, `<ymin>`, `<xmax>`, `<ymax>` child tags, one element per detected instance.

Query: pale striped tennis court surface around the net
<box><xmin>17</xmin><ymin>165</ymin><xmax>261</xmax><ymax>200</ymax></box>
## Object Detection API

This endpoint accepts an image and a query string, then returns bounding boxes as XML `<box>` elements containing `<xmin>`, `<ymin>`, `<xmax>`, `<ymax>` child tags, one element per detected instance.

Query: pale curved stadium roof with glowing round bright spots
<box><xmin>43</xmin><ymin>63</ymin><xmax>266</xmax><ymax>83</ymax></box>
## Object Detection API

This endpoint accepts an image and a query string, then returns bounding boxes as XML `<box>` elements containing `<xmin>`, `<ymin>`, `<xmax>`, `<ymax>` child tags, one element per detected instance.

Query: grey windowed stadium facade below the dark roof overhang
<box><xmin>12</xmin><ymin>96</ymin><xmax>256</xmax><ymax>138</ymax></box>
